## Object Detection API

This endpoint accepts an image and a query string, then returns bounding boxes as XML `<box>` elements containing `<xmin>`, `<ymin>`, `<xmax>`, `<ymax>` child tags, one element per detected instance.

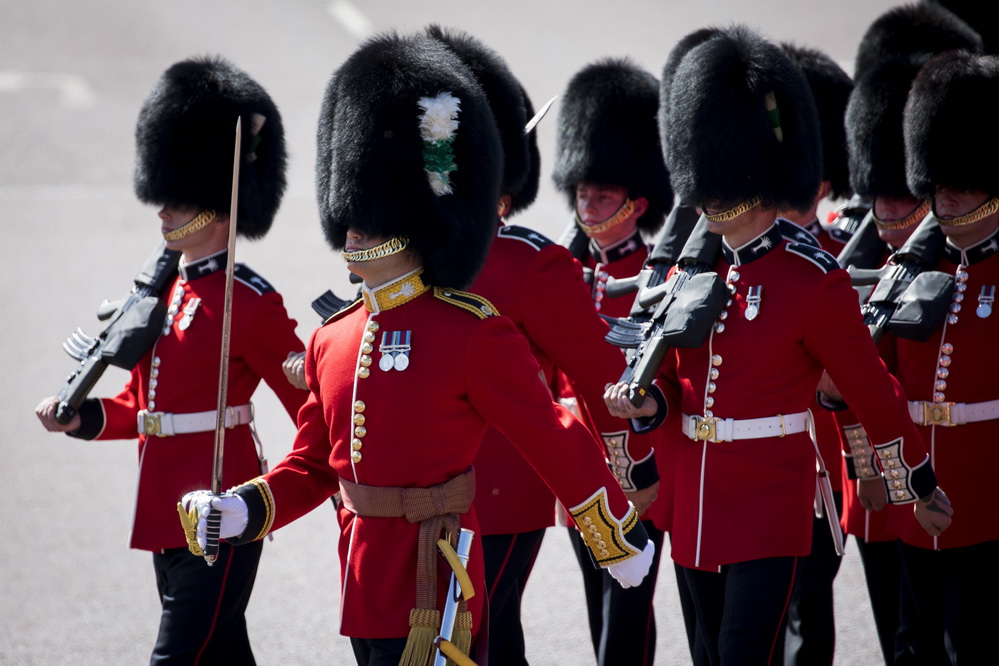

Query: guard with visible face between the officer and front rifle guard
<box><xmin>552</xmin><ymin>59</ymin><xmax>673</xmax><ymax>664</ymax></box>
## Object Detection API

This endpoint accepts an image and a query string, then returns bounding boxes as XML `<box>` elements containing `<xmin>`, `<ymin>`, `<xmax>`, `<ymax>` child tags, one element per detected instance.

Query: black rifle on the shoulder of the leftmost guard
<box><xmin>55</xmin><ymin>243</ymin><xmax>180</xmax><ymax>425</ymax></box>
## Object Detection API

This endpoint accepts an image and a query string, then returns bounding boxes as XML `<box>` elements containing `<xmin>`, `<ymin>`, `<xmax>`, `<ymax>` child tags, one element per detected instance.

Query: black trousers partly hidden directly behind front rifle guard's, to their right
<box><xmin>784</xmin><ymin>493</ymin><xmax>843</xmax><ymax>666</ymax></box>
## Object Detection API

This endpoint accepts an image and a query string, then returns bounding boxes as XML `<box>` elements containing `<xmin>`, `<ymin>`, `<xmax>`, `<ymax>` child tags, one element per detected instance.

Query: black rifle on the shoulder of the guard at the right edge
<box><xmin>847</xmin><ymin>215</ymin><xmax>945</xmax><ymax>342</ymax></box>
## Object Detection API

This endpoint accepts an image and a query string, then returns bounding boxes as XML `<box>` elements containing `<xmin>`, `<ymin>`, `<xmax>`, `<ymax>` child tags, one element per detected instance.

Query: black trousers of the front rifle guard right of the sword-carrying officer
<box><xmin>681</xmin><ymin>557</ymin><xmax>797</xmax><ymax>666</ymax></box>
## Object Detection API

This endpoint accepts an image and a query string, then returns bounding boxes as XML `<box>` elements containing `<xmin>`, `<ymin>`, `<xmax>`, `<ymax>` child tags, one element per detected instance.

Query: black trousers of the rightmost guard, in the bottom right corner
<box><xmin>895</xmin><ymin>541</ymin><xmax>999</xmax><ymax>666</ymax></box>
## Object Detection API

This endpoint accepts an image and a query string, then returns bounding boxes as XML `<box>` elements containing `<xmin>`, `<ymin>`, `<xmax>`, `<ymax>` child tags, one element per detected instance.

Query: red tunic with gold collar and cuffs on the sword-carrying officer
<box><xmin>251</xmin><ymin>273</ymin><xmax>640</xmax><ymax>638</ymax></box>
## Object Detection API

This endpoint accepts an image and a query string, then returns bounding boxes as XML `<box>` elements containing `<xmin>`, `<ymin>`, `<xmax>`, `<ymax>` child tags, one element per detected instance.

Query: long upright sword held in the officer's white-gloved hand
<box><xmin>205</xmin><ymin>117</ymin><xmax>243</xmax><ymax>566</ymax></box>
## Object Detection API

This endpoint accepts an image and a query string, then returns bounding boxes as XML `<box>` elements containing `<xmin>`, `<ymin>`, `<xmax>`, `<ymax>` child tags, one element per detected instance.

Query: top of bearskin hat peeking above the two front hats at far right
<box><xmin>853</xmin><ymin>2</ymin><xmax>982</xmax><ymax>81</ymax></box>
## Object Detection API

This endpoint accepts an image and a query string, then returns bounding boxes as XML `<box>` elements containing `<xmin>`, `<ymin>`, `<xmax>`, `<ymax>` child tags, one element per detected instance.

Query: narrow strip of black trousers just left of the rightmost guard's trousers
<box><xmin>854</xmin><ymin>537</ymin><xmax>902</xmax><ymax>664</ymax></box>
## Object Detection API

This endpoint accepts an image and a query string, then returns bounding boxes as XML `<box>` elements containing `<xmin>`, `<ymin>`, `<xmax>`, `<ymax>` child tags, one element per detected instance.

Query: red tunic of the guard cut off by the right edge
<box><xmin>889</xmin><ymin>234</ymin><xmax>999</xmax><ymax>549</ymax></box>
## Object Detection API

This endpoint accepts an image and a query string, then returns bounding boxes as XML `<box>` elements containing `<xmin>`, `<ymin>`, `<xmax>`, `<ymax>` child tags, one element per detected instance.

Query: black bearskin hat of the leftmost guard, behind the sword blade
<box><xmin>133</xmin><ymin>57</ymin><xmax>287</xmax><ymax>238</ymax></box>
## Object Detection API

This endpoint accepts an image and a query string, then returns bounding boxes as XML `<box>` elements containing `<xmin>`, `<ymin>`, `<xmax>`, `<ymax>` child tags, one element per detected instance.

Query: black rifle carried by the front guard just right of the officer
<box><xmin>605</xmin><ymin>216</ymin><xmax>729</xmax><ymax>407</ymax></box>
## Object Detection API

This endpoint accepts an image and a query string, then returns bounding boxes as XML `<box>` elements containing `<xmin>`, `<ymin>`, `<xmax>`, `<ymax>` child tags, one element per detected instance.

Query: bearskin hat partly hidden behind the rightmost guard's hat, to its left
<box><xmin>846</xmin><ymin>54</ymin><xmax>926</xmax><ymax>198</ymax></box>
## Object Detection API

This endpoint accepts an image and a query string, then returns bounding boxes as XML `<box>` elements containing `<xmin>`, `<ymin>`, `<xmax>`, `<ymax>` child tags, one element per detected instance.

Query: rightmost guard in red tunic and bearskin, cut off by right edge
<box><xmin>889</xmin><ymin>51</ymin><xmax>999</xmax><ymax>664</ymax></box>
